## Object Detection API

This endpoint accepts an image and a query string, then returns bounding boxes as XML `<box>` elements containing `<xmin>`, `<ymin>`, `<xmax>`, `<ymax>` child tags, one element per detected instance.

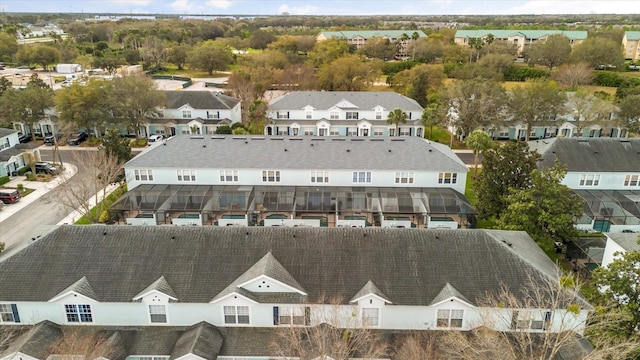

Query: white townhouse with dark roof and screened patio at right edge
<box><xmin>529</xmin><ymin>138</ymin><xmax>640</xmax><ymax>233</ymax></box>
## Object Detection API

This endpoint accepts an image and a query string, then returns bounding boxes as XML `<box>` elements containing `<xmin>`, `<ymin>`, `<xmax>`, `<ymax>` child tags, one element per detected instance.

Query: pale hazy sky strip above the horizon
<box><xmin>0</xmin><ymin>0</ymin><xmax>640</xmax><ymax>15</ymax></box>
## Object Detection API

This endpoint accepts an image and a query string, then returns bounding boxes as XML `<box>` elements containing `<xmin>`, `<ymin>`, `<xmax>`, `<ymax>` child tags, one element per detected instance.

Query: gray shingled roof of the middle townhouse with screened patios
<box><xmin>125</xmin><ymin>135</ymin><xmax>468</xmax><ymax>172</ymax></box>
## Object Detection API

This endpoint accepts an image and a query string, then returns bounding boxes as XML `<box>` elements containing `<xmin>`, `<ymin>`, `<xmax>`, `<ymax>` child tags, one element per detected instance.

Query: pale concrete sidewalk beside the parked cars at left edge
<box><xmin>0</xmin><ymin>163</ymin><xmax>78</xmax><ymax>222</ymax></box>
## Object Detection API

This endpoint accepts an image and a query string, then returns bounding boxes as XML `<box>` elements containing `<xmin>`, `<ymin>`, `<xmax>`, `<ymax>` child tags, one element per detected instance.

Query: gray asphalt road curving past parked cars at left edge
<box><xmin>0</xmin><ymin>149</ymin><xmax>85</xmax><ymax>253</ymax></box>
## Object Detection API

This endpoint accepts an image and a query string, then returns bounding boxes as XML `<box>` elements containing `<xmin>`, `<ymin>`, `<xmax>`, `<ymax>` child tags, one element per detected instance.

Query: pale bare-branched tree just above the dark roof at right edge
<box><xmin>566</xmin><ymin>89</ymin><xmax>617</xmax><ymax>136</ymax></box>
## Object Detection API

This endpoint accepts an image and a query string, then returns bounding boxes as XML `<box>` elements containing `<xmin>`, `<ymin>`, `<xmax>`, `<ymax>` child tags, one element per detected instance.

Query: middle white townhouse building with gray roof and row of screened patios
<box><xmin>111</xmin><ymin>135</ymin><xmax>475</xmax><ymax>228</ymax></box>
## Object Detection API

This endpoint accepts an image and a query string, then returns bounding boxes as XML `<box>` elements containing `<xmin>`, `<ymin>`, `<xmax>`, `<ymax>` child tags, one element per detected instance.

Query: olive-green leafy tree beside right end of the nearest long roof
<box><xmin>498</xmin><ymin>162</ymin><xmax>583</xmax><ymax>246</ymax></box>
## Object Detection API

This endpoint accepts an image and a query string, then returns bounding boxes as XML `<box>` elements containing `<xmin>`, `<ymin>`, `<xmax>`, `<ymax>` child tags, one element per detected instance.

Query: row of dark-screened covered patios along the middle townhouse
<box><xmin>109</xmin><ymin>185</ymin><xmax>476</xmax><ymax>228</ymax></box>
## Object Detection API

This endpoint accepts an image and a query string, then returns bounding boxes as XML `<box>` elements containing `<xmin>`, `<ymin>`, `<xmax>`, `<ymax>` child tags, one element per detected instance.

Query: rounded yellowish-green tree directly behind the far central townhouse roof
<box><xmin>318</xmin><ymin>55</ymin><xmax>378</xmax><ymax>91</ymax></box>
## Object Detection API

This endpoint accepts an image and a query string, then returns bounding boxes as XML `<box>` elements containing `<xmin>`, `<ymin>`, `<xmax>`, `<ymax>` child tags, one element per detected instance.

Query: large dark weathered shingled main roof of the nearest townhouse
<box><xmin>0</xmin><ymin>225</ymin><xmax>588</xmax><ymax>306</ymax></box>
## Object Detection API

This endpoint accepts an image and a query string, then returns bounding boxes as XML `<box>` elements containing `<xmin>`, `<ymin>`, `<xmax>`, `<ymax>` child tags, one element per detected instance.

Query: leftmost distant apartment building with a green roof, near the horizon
<box><xmin>316</xmin><ymin>30</ymin><xmax>427</xmax><ymax>60</ymax></box>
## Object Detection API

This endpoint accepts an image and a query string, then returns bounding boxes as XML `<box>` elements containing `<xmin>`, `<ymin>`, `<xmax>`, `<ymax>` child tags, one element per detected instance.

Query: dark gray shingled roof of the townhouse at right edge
<box><xmin>529</xmin><ymin>138</ymin><xmax>640</xmax><ymax>172</ymax></box>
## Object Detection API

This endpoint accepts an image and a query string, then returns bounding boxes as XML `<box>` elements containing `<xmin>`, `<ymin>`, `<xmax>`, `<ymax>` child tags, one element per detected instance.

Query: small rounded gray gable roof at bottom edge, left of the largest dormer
<box><xmin>169</xmin><ymin>321</ymin><xmax>224</xmax><ymax>360</ymax></box>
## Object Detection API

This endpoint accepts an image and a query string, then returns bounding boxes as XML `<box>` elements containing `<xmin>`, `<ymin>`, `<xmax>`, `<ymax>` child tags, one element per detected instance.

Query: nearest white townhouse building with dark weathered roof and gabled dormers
<box><xmin>0</xmin><ymin>225</ymin><xmax>591</xmax><ymax>360</ymax></box>
